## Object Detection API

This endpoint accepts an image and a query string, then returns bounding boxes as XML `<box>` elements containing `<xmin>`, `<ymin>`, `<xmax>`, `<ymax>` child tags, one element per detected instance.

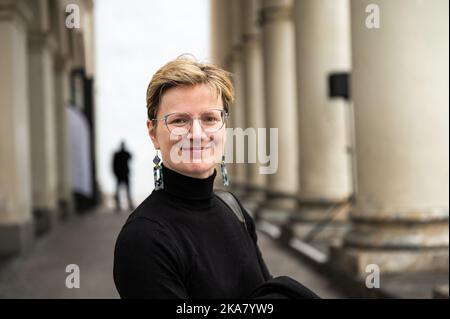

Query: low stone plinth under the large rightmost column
<box><xmin>329</xmin><ymin>246</ymin><xmax>449</xmax><ymax>278</ymax></box>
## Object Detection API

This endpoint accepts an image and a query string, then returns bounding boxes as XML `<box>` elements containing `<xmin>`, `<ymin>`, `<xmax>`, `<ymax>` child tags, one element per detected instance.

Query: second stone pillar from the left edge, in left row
<box><xmin>28</xmin><ymin>0</ymin><xmax>58</xmax><ymax>234</ymax></box>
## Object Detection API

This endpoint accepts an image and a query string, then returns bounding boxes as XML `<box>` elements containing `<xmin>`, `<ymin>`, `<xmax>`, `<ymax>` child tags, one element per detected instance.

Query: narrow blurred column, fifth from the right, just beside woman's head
<box><xmin>228</xmin><ymin>0</ymin><xmax>248</xmax><ymax>195</ymax></box>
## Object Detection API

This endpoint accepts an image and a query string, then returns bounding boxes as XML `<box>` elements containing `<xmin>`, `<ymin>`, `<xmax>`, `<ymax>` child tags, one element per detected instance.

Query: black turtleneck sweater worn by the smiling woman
<box><xmin>114</xmin><ymin>166</ymin><xmax>272</xmax><ymax>298</ymax></box>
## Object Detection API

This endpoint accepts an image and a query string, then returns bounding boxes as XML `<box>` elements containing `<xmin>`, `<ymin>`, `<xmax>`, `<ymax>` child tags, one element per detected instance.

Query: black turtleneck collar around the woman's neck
<box><xmin>162</xmin><ymin>164</ymin><xmax>217</xmax><ymax>200</ymax></box>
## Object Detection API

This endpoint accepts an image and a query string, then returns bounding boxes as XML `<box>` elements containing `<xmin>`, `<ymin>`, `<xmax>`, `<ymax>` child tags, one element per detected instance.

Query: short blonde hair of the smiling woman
<box><xmin>147</xmin><ymin>55</ymin><xmax>234</xmax><ymax>120</ymax></box>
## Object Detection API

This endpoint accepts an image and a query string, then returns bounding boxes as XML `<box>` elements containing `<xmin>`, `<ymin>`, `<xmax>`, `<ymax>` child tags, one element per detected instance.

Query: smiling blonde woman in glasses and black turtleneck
<box><xmin>114</xmin><ymin>57</ymin><xmax>316</xmax><ymax>298</ymax></box>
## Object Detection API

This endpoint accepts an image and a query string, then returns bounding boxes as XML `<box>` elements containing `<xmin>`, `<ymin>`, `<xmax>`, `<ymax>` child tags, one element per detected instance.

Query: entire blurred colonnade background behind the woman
<box><xmin>0</xmin><ymin>0</ymin><xmax>449</xmax><ymax>298</ymax></box>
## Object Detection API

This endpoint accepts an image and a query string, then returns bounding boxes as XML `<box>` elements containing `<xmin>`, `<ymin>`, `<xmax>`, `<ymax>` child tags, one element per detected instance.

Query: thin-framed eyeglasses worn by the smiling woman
<box><xmin>152</xmin><ymin>109</ymin><xmax>228</xmax><ymax>135</ymax></box>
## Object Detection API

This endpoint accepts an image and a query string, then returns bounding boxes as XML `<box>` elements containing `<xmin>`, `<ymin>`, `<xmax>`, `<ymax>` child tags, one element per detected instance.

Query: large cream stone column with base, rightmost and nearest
<box><xmin>332</xmin><ymin>0</ymin><xmax>449</xmax><ymax>276</ymax></box>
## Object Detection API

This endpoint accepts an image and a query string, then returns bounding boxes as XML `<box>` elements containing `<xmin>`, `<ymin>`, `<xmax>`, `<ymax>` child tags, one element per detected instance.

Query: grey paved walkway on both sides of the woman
<box><xmin>0</xmin><ymin>210</ymin><xmax>344</xmax><ymax>298</ymax></box>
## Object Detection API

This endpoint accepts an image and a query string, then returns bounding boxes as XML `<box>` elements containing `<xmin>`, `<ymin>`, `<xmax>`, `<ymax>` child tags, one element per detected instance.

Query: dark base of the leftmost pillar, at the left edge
<box><xmin>0</xmin><ymin>221</ymin><xmax>34</xmax><ymax>257</ymax></box>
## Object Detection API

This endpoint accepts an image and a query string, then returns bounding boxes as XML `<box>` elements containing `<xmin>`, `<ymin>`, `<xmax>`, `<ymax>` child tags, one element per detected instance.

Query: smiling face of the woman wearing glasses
<box><xmin>147</xmin><ymin>84</ymin><xmax>226</xmax><ymax>178</ymax></box>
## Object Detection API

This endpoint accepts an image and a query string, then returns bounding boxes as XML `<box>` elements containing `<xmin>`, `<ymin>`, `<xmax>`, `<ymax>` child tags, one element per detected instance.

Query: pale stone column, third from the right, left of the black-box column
<box><xmin>261</xmin><ymin>0</ymin><xmax>299</xmax><ymax>215</ymax></box>
